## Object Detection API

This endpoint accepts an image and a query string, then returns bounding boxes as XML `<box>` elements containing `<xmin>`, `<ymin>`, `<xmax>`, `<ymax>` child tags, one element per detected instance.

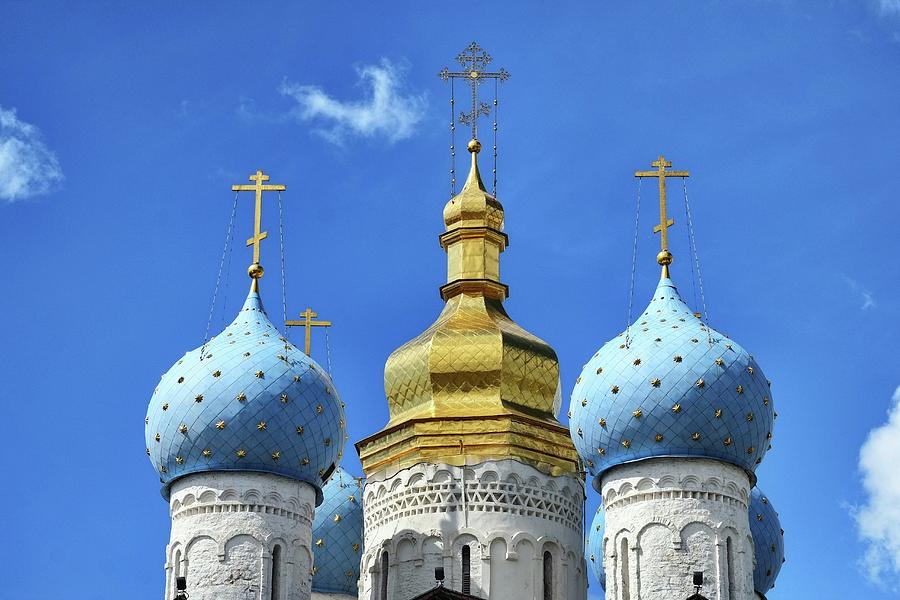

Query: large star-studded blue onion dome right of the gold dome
<box><xmin>569</xmin><ymin>278</ymin><xmax>775</xmax><ymax>491</ymax></box>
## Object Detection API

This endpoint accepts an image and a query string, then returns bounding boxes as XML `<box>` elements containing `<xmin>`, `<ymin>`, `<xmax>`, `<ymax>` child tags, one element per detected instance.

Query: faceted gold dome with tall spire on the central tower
<box><xmin>357</xmin><ymin>144</ymin><xmax>578</xmax><ymax>475</ymax></box>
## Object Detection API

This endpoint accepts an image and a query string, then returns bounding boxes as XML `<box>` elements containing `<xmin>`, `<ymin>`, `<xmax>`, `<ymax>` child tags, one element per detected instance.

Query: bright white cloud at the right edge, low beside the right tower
<box><xmin>854</xmin><ymin>387</ymin><xmax>900</xmax><ymax>591</ymax></box>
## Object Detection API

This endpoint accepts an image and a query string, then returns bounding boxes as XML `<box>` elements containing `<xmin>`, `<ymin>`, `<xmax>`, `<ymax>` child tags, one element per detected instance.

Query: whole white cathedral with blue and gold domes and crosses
<box><xmin>145</xmin><ymin>48</ymin><xmax>784</xmax><ymax>600</ymax></box>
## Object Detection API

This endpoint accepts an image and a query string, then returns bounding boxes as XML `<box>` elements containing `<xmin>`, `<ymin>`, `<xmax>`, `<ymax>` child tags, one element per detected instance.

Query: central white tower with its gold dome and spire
<box><xmin>357</xmin><ymin>132</ymin><xmax>586</xmax><ymax>600</ymax></box>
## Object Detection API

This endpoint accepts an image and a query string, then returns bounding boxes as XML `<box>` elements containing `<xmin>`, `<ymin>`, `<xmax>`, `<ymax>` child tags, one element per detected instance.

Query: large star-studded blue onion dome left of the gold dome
<box><xmin>145</xmin><ymin>290</ymin><xmax>345</xmax><ymax>501</ymax></box>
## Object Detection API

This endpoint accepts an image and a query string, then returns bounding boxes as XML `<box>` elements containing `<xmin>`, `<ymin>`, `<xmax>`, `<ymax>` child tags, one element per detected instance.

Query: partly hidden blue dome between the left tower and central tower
<box><xmin>312</xmin><ymin>467</ymin><xmax>363</xmax><ymax>597</ymax></box>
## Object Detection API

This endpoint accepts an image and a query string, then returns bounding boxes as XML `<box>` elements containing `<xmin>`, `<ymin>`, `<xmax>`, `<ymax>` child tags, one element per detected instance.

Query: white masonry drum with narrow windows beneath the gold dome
<box><xmin>359</xmin><ymin>460</ymin><xmax>587</xmax><ymax>600</ymax></box>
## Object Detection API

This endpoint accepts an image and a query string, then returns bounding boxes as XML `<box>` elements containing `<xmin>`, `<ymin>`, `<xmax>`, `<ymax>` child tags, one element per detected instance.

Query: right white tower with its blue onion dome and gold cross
<box><xmin>570</xmin><ymin>157</ymin><xmax>775</xmax><ymax>600</ymax></box>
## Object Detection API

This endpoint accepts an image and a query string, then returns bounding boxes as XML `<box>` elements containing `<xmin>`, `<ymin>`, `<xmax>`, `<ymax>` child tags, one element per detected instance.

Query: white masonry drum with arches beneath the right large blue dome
<box><xmin>602</xmin><ymin>458</ymin><xmax>757</xmax><ymax>600</ymax></box>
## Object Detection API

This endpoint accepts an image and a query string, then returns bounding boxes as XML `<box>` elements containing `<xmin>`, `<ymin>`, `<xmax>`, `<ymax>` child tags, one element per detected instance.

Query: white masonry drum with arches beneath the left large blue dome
<box><xmin>166</xmin><ymin>472</ymin><xmax>316</xmax><ymax>600</ymax></box>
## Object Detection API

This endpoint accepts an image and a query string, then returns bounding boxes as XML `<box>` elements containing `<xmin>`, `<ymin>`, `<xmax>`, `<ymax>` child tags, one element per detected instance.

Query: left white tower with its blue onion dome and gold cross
<box><xmin>145</xmin><ymin>172</ymin><xmax>345</xmax><ymax>600</ymax></box>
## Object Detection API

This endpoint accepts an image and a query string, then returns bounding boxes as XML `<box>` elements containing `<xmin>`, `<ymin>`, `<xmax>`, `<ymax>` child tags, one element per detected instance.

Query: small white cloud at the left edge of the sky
<box><xmin>0</xmin><ymin>106</ymin><xmax>63</xmax><ymax>202</ymax></box>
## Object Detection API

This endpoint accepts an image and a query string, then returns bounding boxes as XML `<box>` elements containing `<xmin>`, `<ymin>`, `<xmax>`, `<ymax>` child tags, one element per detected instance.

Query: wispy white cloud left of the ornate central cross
<box><xmin>280</xmin><ymin>58</ymin><xmax>427</xmax><ymax>145</ymax></box>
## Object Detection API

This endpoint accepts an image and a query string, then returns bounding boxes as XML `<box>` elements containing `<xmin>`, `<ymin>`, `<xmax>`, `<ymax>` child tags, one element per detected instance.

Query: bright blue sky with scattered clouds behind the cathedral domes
<box><xmin>0</xmin><ymin>0</ymin><xmax>900</xmax><ymax>600</ymax></box>
